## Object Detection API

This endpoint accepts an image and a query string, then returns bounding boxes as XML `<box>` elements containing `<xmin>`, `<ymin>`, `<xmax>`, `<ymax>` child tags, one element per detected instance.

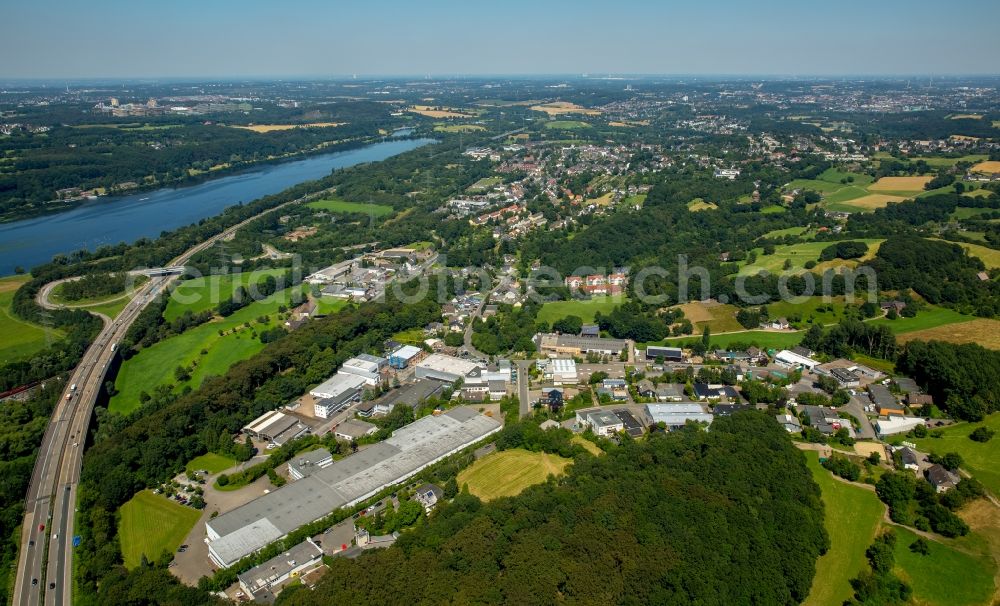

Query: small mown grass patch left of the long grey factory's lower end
<box><xmin>118</xmin><ymin>490</ymin><xmax>201</xmax><ymax>568</ymax></box>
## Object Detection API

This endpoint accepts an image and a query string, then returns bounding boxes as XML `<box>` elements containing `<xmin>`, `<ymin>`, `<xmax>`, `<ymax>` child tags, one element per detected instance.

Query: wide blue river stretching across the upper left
<box><xmin>0</xmin><ymin>137</ymin><xmax>435</xmax><ymax>276</ymax></box>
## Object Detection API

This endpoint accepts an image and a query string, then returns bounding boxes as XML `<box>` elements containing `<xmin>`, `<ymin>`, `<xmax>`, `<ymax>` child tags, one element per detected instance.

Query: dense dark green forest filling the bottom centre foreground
<box><xmin>279</xmin><ymin>412</ymin><xmax>829</xmax><ymax>606</ymax></box>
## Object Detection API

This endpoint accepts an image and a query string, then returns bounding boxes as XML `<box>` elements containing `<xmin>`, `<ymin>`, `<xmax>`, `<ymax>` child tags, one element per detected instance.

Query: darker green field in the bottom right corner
<box><xmin>893</xmin><ymin>527</ymin><xmax>995</xmax><ymax>606</ymax></box>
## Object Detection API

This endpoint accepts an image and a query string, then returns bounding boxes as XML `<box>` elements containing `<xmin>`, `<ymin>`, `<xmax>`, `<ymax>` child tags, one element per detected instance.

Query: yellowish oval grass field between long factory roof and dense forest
<box><xmin>458</xmin><ymin>448</ymin><xmax>572</xmax><ymax>501</ymax></box>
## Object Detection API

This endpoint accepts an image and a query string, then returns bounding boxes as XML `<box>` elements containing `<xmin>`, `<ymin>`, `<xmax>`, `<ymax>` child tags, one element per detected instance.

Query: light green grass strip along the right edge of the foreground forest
<box><xmin>803</xmin><ymin>452</ymin><xmax>885</xmax><ymax>606</ymax></box>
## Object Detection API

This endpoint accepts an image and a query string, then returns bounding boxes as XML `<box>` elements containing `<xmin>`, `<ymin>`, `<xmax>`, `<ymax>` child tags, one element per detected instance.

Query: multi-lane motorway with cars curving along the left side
<box><xmin>14</xmin><ymin>192</ymin><xmax>325</xmax><ymax>606</ymax></box>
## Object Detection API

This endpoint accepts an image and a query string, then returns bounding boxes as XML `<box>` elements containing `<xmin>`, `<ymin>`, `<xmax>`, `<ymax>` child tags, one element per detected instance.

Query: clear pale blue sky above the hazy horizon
<box><xmin>0</xmin><ymin>0</ymin><xmax>1000</xmax><ymax>78</ymax></box>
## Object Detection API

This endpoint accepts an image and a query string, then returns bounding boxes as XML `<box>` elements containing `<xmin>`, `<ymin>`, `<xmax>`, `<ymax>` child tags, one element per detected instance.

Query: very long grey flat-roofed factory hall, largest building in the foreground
<box><xmin>205</xmin><ymin>408</ymin><xmax>502</xmax><ymax>567</ymax></box>
